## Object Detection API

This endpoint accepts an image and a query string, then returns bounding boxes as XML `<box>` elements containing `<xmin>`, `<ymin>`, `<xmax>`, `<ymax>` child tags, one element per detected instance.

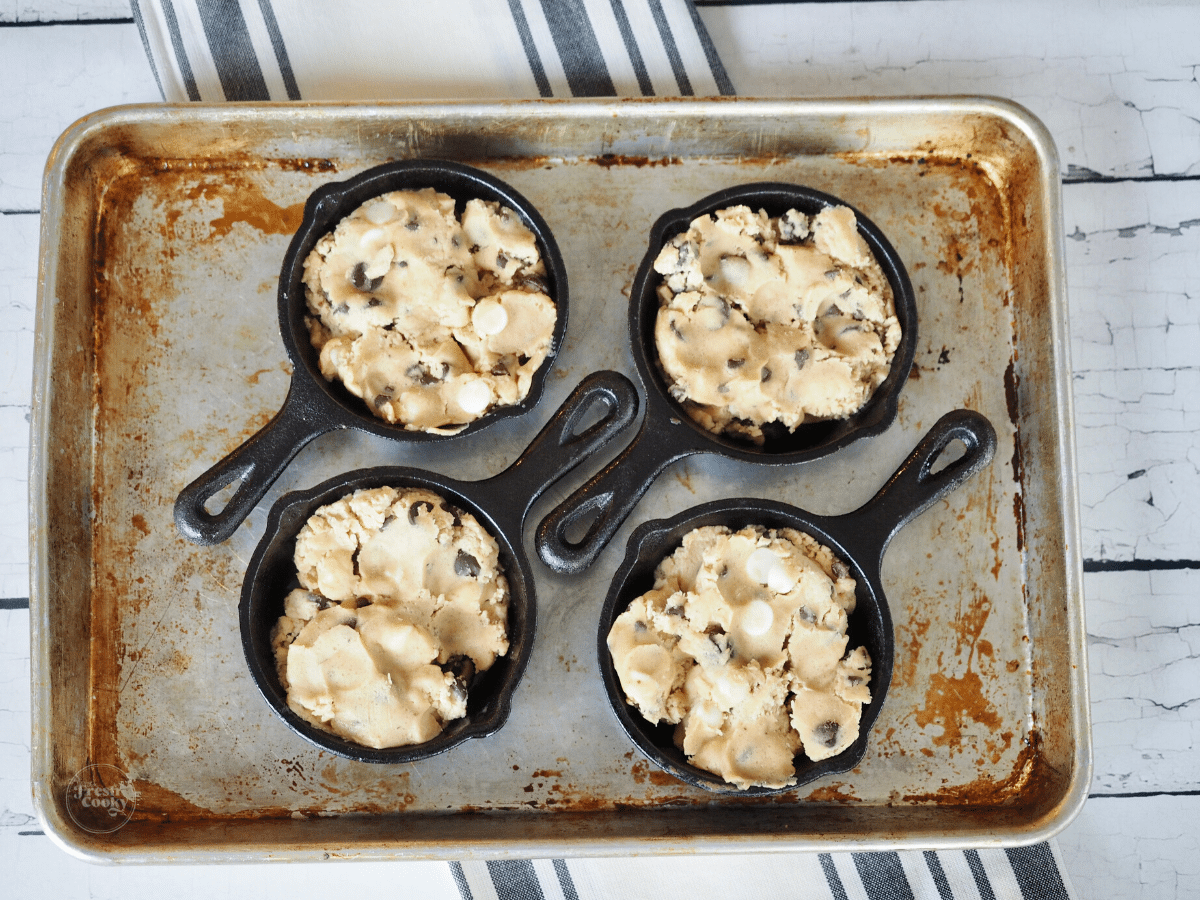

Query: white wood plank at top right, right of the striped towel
<box><xmin>700</xmin><ymin>0</ymin><xmax>1200</xmax><ymax>176</ymax></box>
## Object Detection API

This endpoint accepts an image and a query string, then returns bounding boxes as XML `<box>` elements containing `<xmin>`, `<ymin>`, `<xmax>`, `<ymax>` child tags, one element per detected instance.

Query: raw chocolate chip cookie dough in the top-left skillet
<box><xmin>304</xmin><ymin>188</ymin><xmax>558</xmax><ymax>434</ymax></box>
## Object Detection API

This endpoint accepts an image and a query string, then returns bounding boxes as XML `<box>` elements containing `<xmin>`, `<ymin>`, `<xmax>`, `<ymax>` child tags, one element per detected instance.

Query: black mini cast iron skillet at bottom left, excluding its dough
<box><xmin>240</xmin><ymin>372</ymin><xmax>637</xmax><ymax>762</ymax></box>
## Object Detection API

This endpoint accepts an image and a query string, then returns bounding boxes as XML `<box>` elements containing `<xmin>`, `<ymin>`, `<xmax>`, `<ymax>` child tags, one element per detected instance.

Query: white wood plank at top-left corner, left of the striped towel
<box><xmin>0</xmin><ymin>24</ymin><xmax>162</xmax><ymax>211</ymax></box>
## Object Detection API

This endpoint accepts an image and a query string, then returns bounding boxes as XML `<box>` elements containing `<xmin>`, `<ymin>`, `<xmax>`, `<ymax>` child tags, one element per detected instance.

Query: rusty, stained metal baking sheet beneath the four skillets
<box><xmin>32</xmin><ymin>100</ymin><xmax>1090</xmax><ymax>862</ymax></box>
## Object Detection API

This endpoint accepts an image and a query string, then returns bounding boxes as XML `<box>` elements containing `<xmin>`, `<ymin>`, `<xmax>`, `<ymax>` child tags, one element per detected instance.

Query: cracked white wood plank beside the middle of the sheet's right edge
<box><xmin>1063</xmin><ymin>181</ymin><xmax>1200</xmax><ymax>560</ymax></box>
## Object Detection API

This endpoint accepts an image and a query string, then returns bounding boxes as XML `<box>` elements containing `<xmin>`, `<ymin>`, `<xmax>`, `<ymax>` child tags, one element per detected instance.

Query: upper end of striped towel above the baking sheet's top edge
<box><xmin>133</xmin><ymin>0</ymin><xmax>733</xmax><ymax>102</ymax></box>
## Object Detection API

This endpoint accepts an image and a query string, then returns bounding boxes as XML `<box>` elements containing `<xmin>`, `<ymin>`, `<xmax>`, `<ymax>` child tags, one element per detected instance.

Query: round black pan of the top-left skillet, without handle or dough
<box><xmin>277</xmin><ymin>160</ymin><xmax>568</xmax><ymax>442</ymax></box>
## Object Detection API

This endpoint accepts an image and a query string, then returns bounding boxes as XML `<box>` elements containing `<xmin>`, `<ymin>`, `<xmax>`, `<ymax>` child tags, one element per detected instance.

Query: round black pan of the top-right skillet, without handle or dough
<box><xmin>629</xmin><ymin>181</ymin><xmax>917</xmax><ymax>462</ymax></box>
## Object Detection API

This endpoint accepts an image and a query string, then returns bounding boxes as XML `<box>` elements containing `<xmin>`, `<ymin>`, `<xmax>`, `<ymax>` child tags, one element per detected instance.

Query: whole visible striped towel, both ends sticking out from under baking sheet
<box><xmin>133</xmin><ymin>0</ymin><xmax>1072</xmax><ymax>900</ymax></box>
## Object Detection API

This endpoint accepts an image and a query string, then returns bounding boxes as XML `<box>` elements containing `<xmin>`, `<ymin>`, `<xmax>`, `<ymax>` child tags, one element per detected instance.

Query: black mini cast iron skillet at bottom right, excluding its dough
<box><xmin>598</xmin><ymin>409</ymin><xmax>996</xmax><ymax>797</ymax></box>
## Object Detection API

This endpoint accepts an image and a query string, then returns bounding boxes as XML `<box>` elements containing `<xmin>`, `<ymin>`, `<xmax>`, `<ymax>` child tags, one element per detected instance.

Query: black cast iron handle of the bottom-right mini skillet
<box><xmin>841</xmin><ymin>409</ymin><xmax>996</xmax><ymax>562</ymax></box>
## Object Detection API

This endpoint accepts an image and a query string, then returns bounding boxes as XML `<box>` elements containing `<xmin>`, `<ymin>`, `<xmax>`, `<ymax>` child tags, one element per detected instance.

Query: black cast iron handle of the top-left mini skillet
<box><xmin>175</xmin><ymin>382</ymin><xmax>337</xmax><ymax>545</ymax></box>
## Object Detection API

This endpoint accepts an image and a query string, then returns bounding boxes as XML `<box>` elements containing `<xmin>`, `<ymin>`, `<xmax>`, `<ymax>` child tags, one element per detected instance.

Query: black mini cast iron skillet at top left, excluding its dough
<box><xmin>175</xmin><ymin>160</ymin><xmax>566</xmax><ymax>544</ymax></box>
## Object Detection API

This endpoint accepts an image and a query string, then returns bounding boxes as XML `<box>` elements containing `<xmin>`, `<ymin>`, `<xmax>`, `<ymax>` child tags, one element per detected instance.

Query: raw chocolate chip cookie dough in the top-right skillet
<box><xmin>654</xmin><ymin>206</ymin><xmax>900</xmax><ymax>444</ymax></box>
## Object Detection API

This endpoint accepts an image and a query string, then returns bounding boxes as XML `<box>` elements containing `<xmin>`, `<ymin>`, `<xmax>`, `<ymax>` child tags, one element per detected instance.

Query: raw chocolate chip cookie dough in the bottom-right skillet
<box><xmin>608</xmin><ymin>526</ymin><xmax>871</xmax><ymax>788</ymax></box>
